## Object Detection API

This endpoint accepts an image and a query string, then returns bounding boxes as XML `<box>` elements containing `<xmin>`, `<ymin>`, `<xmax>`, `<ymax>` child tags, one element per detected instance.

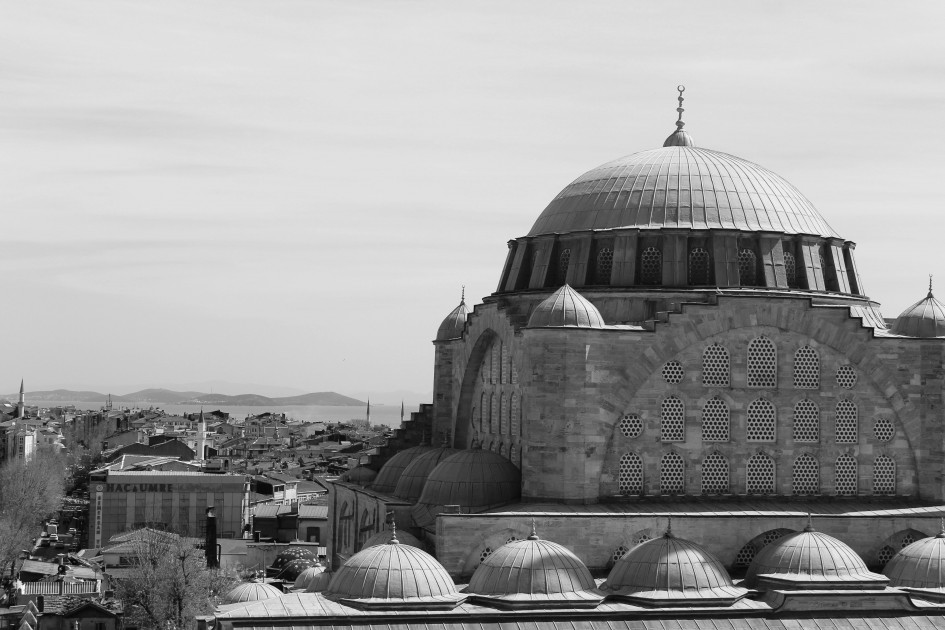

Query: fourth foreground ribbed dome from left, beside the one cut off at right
<box><xmin>745</xmin><ymin>525</ymin><xmax>888</xmax><ymax>589</ymax></box>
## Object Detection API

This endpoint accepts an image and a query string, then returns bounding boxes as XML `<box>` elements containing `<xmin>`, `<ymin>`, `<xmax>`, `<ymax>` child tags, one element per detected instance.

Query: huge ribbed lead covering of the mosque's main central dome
<box><xmin>528</xmin><ymin>146</ymin><xmax>837</xmax><ymax>237</ymax></box>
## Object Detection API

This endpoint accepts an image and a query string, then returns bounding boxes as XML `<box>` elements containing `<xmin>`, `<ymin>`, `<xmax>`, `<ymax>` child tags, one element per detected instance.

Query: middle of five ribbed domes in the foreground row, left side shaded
<box><xmin>601</xmin><ymin>531</ymin><xmax>748</xmax><ymax>606</ymax></box>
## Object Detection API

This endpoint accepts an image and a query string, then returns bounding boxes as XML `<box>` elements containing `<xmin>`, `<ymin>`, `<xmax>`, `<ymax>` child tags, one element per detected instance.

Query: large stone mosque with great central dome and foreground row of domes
<box><xmin>205</xmin><ymin>86</ymin><xmax>945</xmax><ymax>630</ymax></box>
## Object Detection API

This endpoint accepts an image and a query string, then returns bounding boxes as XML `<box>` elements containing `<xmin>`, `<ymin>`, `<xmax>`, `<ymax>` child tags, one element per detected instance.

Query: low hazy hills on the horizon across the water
<box><xmin>19</xmin><ymin>389</ymin><xmax>367</xmax><ymax>407</ymax></box>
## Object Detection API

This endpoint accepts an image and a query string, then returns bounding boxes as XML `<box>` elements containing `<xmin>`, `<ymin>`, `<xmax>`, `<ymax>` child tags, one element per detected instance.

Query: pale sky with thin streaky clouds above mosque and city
<box><xmin>0</xmin><ymin>0</ymin><xmax>945</xmax><ymax>399</ymax></box>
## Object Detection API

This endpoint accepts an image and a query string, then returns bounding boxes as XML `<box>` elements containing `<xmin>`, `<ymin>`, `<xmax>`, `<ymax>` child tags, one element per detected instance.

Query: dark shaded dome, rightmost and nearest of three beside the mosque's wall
<box><xmin>413</xmin><ymin>449</ymin><xmax>522</xmax><ymax>527</ymax></box>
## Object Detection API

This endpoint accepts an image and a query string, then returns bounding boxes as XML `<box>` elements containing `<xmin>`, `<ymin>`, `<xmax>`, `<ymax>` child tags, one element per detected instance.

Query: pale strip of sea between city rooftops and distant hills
<box><xmin>34</xmin><ymin>400</ymin><xmax>417</xmax><ymax>429</ymax></box>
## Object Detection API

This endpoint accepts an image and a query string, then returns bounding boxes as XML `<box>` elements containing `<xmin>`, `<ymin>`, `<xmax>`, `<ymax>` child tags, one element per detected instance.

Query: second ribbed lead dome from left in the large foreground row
<box><xmin>466</xmin><ymin>527</ymin><xmax>603</xmax><ymax>608</ymax></box>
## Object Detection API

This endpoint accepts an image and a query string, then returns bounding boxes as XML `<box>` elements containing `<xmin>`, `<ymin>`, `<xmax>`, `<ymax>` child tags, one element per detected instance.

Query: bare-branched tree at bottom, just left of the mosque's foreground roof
<box><xmin>115</xmin><ymin>529</ymin><xmax>237</xmax><ymax>630</ymax></box>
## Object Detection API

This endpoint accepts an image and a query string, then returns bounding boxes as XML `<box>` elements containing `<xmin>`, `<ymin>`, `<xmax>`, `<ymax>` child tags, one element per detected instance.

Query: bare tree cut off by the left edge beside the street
<box><xmin>0</xmin><ymin>450</ymin><xmax>65</xmax><ymax>573</ymax></box>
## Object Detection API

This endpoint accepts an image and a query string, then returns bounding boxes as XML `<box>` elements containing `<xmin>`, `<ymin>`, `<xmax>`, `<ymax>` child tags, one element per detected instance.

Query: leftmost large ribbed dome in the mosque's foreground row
<box><xmin>325</xmin><ymin>538</ymin><xmax>465</xmax><ymax>609</ymax></box>
